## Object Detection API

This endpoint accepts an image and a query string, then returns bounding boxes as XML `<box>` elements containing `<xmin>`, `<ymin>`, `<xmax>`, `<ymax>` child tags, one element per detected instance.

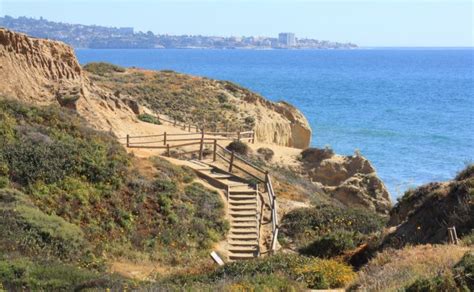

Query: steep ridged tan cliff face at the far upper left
<box><xmin>0</xmin><ymin>29</ymin><xmax>84</xmax><ymax>103</ymax></box>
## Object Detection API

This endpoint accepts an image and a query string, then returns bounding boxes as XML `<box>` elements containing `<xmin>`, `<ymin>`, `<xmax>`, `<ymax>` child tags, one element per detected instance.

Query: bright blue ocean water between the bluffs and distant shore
<box><xmin>77</xmin><ymin>49</ymin><xmax>474</xmax><ymax>198</ymax></box>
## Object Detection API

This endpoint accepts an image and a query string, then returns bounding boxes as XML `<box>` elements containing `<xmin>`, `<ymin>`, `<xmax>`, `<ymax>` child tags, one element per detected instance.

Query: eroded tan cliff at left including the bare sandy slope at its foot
<box><xmin>0</xmin><ymin>28</ymin><xmax>138</xmax><ymax>131</ymax></box>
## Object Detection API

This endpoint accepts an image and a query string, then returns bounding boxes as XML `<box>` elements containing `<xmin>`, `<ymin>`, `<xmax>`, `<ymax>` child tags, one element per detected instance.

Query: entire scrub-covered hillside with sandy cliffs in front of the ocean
<box><xmin>0</xmin><ymin>29</ymin><xmax>474</xmax><ymax>291</ymax></box>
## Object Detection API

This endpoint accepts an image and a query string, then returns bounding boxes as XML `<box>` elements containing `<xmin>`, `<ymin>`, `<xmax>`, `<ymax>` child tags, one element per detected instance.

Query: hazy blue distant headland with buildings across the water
<box><xmin>0</xmin><ymin>16</ymin><xmax>357</xmax><ymax>49</ymax></box>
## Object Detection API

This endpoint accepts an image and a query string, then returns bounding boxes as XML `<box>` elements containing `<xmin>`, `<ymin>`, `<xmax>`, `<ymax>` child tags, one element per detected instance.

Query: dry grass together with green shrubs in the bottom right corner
<box><xmin>353</xmin><ymin>245</ymin><xmax>472</xmax><ymax>291</ymax></box>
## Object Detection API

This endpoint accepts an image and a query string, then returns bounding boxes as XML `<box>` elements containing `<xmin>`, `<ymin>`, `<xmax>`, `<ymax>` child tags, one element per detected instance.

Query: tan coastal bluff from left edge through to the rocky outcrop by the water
<box><xmin>0</xmin><ymin>29</ymin><xmax>391</xmax><ymax>214</ymax></box>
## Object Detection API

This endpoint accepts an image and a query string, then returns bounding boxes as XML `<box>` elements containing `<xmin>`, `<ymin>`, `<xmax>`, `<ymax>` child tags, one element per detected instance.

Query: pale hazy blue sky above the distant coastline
<box><xmin>0</xmin><ymin>0</ymin><xmax>474</xmax><ymax>46</ymax></box>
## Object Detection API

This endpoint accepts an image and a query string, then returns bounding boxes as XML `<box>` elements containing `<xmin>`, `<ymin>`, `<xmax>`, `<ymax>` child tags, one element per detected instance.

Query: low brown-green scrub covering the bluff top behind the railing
<box><xmin>84</xmin><ymin>63</ymin><xmax>261</xmax><ymax>131</ymax></box>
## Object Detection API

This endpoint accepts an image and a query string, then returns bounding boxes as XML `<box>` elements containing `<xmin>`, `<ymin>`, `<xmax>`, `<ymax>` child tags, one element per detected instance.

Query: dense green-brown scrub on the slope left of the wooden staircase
<box><xmin>0</xmin><ymin>100</ymin><xmax>228</xmax><ymax>290</ymax></box>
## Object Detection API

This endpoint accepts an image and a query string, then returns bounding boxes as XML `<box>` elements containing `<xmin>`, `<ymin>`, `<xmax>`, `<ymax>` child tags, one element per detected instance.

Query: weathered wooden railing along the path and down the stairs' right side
<box><xmin>126</xmin><ymin>131</ymin><xmax>279</xmax><ymax>252</ymax></box>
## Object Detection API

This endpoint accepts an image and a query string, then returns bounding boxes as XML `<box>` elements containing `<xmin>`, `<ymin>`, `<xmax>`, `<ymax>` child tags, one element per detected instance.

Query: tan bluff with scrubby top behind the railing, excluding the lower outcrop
<box><xmin>0</xmin><ymin>28</ymin><xmax>311</xmax><ymax>149</ymax></box>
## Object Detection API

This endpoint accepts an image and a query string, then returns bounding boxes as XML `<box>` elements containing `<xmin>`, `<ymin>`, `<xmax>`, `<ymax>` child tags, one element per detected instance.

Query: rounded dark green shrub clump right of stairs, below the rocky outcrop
<box><xmin>281</xmin><ymin>205</ymin><xmax>386</xmax><ymax>258</ymax></box>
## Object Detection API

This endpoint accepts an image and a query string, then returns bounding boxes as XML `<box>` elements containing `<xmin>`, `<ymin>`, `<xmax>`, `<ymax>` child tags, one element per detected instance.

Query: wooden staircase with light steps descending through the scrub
<box><xmin>187</xmin><ymin>160</ymin><xmax>261</xmax><ymax>261</ymax></box>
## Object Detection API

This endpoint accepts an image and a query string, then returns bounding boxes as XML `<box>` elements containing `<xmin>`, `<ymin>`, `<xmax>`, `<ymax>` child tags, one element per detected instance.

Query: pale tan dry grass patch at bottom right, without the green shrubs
<box><xmin>354</xmin><ymin>244</ymin><xmax>473</xmax><ymax>291</ymax></box>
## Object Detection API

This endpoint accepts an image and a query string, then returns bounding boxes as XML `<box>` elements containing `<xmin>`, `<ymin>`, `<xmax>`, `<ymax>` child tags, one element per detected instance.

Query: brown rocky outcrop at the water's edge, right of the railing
<box><xmin>302</xmin><ymin>148</ymin><xmax>391</xmax><ymax>214</ymax></box>
